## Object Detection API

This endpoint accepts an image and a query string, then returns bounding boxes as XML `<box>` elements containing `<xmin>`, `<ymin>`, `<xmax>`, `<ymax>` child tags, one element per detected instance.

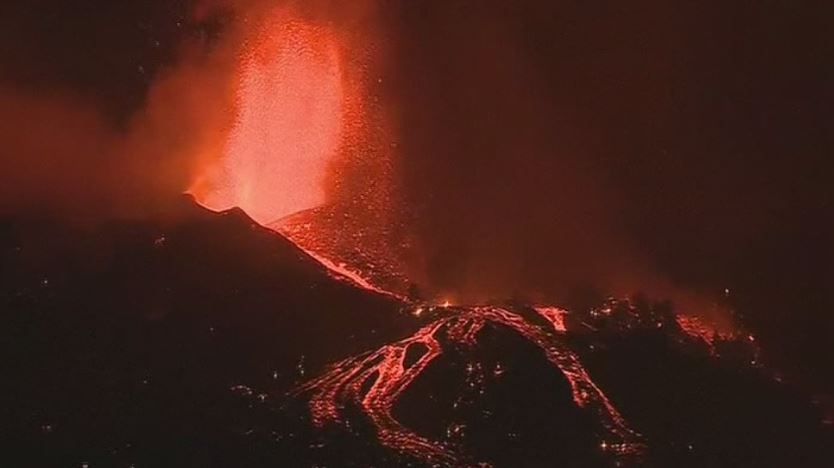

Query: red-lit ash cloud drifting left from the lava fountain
<box><xmin>0</xmin><ymin>51</ymin><xmax>237</xmax><ymax>217</ymax></box>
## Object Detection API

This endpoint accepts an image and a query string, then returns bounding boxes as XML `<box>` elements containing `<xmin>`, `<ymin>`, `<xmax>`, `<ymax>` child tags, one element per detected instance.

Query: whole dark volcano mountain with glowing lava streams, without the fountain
<box><xmin>0</xmin><ymin>199</ymin><xmax>832</xmax><ymax>467</ymax></box>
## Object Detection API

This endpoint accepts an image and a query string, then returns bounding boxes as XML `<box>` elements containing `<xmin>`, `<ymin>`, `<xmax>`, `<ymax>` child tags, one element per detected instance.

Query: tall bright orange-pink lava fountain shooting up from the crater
<box><xmin>190</xmin><ymin>11</ymin><xmax>344</xmax><ymax>223</ymax></box>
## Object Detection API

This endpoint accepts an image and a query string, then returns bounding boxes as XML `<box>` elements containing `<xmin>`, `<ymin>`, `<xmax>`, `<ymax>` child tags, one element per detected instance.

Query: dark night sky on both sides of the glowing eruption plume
<box><xmin>0</xmin><ymin>0</ymin><xmax>834</xmax><ymax>384</ymax></box>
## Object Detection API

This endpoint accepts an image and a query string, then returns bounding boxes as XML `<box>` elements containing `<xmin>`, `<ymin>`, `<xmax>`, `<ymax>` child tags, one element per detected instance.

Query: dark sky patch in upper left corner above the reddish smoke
<box><xmin>0</xmin><ymin>0</ymin><xmax>188</xmax><ymax>117</ymax></box>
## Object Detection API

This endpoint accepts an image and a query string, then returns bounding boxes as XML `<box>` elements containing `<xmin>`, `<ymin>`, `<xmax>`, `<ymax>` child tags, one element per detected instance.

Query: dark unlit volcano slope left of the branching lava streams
<box><xmin>0</xmin><ymin>199</ymin><xmax>413</xmax><ymax>467</ymax></box>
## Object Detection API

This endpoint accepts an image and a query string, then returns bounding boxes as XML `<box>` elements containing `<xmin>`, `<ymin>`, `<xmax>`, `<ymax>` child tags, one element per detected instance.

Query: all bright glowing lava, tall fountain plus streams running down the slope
<box><xmin>180</xmin><ymin>9</ymin><xmax>792</xmax><ymax>466</ymax></box>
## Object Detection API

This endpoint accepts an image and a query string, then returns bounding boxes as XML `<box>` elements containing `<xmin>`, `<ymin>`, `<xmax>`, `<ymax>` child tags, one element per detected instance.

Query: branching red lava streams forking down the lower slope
<box><xmin>296</xmin><ymin>307</ymin><xmax>644</xmax><ymax>465</ymax></box>
